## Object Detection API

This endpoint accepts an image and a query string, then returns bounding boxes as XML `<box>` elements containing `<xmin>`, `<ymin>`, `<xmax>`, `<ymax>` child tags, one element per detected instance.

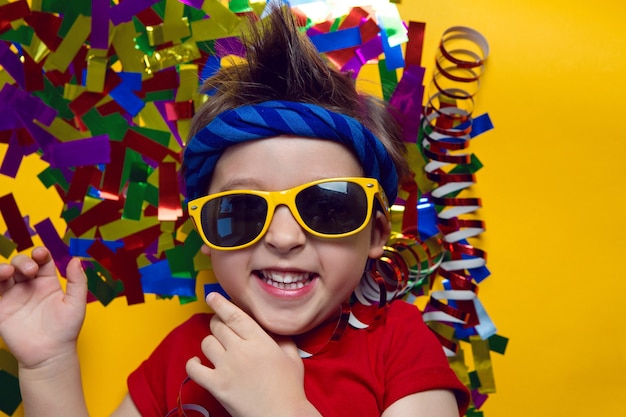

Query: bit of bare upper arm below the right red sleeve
<box><xmin>382</xmin><ymin>390</ymin><xmax>459</xmax><ymax>417</ymax></box>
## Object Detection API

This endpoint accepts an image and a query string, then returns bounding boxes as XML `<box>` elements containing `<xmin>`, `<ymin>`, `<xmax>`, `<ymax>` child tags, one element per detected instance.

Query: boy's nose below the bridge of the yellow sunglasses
<box><xmin>264</xmin><ymin>206</ymin><xmax>306</xmax><ymax>253</ymax></box>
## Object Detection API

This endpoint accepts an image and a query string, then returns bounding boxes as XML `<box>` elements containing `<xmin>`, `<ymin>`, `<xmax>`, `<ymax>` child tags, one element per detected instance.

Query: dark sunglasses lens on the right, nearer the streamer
<box><xmin>296</xmin><ymin>181</ymin><xmax>368</xmax><ymax>235</ymax></box>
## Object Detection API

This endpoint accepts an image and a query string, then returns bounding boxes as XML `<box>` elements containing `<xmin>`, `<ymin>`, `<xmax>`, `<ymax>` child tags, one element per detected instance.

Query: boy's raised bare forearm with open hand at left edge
<box><xmin>0</xmin><ymin>247</ymin><xmax>87</xmax><ymax>417</ymax></box>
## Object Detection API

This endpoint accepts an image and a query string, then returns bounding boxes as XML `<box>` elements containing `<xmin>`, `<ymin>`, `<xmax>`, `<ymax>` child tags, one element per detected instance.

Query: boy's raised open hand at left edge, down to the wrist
<box><xmin>0</xmin><ymin>247</ymin><xmax>87</xmax><ymax>369</ymax></box>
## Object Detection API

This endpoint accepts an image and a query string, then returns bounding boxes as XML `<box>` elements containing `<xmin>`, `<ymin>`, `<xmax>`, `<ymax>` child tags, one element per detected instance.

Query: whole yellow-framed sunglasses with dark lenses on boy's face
<box><xmin>188</xmin><ymin>177</ymin><xmax>389</xmax><ymax>250</ymax></box>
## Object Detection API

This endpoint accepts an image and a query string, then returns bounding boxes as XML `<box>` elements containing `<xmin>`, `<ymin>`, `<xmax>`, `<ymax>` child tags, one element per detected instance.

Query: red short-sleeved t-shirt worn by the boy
<box><xmin>128</xmin><ymin>301</ymin><xmax>469</xmax><ymax>417</ymax></box>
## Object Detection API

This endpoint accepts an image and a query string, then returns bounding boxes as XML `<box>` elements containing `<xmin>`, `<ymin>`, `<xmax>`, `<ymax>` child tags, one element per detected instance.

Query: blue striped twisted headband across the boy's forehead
<box><xmin>184</xmin><ymin>101</ymin><xmax>398</xmax><ymax>204</ymax></box>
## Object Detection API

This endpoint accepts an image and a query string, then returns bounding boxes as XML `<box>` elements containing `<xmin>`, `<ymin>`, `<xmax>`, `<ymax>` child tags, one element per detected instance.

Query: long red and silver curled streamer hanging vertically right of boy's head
<box><xmin>421</xmin><ymin>26</ymin><xmax>489</xmax><ymax>355</ymax></box>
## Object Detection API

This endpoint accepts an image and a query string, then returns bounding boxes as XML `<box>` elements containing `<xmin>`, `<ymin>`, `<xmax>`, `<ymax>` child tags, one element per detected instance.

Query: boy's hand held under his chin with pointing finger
<box><xmin>187</xmin><ymin>293</ymin><xmax>319</xmax><ymax>417</ymax></box>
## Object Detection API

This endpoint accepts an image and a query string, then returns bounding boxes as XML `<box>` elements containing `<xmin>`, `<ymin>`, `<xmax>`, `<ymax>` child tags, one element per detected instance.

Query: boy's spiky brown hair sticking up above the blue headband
<box><xmin>189</xmin><ymin>5</ymin><xmax>410</xmax><ymax>181</ymax></box>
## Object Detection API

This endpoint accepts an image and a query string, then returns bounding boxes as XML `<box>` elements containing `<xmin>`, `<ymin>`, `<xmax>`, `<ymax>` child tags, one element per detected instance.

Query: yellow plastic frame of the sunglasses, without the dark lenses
<box><xmin>187</xmin><ymin>177</ymin><xmax>390</xmax><ymax>250</ymax></box>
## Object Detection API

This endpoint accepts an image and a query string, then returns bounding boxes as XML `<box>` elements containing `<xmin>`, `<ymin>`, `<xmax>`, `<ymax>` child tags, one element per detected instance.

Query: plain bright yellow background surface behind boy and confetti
<box><xmin>0</xmin><ymin>0</ymin><xmax>626</xmax><ymax>417</ymax></box>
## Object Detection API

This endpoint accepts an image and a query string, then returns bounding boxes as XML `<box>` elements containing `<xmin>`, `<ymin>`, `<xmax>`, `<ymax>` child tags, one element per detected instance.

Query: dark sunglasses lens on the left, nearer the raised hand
<box><xmin>200</xmin><ymin>194</ymin><xmax>267</xmax><ymax>248</ymax></box>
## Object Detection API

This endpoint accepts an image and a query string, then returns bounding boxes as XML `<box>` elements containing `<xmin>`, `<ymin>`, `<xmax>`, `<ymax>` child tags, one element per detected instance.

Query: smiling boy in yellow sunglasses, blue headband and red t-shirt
<box><xmin>0</xmin><ymin>9</ymin><xmax>468</xmax><ymax>417</ymax></box>
